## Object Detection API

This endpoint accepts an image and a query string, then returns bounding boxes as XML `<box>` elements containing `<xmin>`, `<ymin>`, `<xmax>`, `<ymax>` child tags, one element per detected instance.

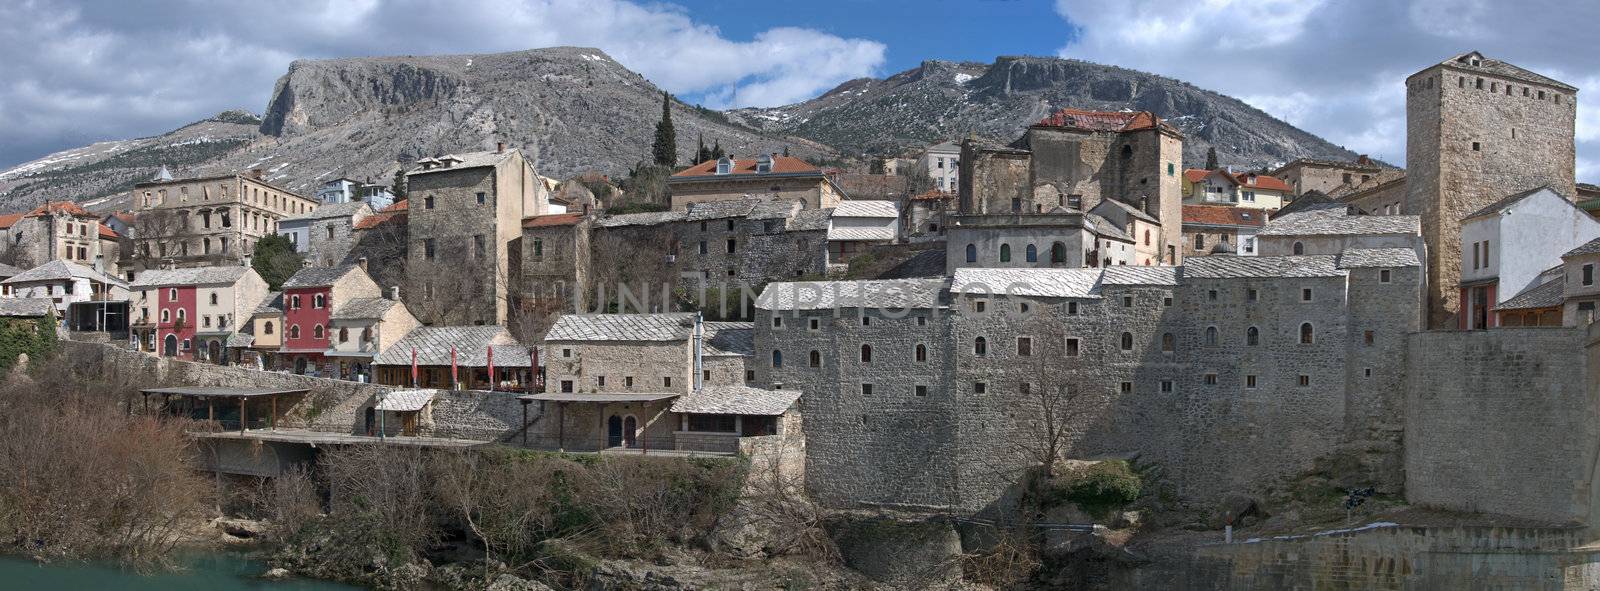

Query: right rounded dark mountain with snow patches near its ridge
<box><xmin>728</xmin><ymin>56</ymin><xmax>1355</xmax><ymax>167</ymax></box>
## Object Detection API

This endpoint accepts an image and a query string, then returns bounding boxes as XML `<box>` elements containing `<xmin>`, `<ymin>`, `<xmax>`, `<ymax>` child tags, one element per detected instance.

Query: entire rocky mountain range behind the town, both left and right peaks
<box><xmin>0</xmin><ymin>46</ymin><xmax>1354</xmax><ymax>211</ymax></box>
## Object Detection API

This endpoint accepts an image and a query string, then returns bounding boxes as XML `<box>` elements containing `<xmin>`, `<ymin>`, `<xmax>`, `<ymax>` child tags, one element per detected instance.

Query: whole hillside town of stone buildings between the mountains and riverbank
<box><xmin>0</xmin><ymin>51</ymin><xmax>1600</xmax><ymax>588</ymax></box>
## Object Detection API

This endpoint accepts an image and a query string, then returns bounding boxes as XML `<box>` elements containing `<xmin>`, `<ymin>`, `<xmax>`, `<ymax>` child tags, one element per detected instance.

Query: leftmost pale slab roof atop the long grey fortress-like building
<box><xmin>755</xmin><ymin>279</ymin><xmax>944</xmax><ymax>311</ymax></box>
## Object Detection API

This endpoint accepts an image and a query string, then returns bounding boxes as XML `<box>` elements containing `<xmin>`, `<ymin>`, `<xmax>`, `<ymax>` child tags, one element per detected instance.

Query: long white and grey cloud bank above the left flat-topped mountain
<box><xmin>0</xmin><ymin>0</ymin><xmax>885</xmax><ymax>167</ymax></box>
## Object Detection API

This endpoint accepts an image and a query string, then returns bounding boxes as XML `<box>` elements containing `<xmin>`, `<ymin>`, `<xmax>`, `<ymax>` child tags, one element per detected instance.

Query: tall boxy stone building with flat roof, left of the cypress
<box><xmin>402</xmin><ymin>144</ymin><xmax>560</xmax><ymax>325</ymax></box>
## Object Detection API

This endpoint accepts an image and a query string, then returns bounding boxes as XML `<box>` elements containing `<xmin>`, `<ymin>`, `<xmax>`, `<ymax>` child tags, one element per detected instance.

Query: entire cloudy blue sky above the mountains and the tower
<box><xmin>0</xmin><ymin>0</ymin><xmax>1600</xmax><ymax>183</ymax></box>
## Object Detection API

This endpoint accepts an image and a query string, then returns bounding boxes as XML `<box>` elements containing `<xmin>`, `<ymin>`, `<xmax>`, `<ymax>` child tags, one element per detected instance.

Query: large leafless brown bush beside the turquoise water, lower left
<box><xmin>0</xmin><ymin>357</ymin><xmax>211</xmax><ymax>564</ymax></box>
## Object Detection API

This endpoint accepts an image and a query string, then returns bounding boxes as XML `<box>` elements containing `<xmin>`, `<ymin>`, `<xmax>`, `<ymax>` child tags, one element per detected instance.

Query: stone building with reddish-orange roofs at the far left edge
<box><xmin>0</xmin><ymin>202</ymin><xmax>120</xmax><ymax>275</ymax></box>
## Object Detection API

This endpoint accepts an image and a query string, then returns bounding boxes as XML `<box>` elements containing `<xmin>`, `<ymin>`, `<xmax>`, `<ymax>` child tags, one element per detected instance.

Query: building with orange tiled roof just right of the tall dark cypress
<box><xmin>667</xmin><ymin>154</ymin><xmax>845</xmax><ymax>210</ymax></box>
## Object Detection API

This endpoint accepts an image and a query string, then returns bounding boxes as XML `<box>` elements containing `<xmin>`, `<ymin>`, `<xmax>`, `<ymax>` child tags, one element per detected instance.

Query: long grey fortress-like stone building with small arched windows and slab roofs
<box><xmin>752</xmin><ymin>241</ymin><xmax>1422</xmax><ymax>511</ymax></box>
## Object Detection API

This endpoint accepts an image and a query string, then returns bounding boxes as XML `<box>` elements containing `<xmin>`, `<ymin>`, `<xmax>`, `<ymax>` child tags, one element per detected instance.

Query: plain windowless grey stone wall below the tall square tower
<box><xmin>1405</xmin><ymin>328</ymin><xmax>1600</xmax><ymax>524</ymax></box>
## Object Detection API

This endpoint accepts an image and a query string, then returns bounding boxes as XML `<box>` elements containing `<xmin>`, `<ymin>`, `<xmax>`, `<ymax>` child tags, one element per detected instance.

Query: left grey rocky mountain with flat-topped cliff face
<box><xmin>0</xmin><ymin>46</ymin><xmax>832</xmax><ymax>210</ymax></box>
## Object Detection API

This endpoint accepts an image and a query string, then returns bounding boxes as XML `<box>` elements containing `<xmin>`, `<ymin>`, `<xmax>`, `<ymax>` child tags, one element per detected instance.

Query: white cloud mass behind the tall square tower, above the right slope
<box><xmin>1056</xmin><ymin>0</ymin><xmax>1600</xmax><ymax>181</ymax></box>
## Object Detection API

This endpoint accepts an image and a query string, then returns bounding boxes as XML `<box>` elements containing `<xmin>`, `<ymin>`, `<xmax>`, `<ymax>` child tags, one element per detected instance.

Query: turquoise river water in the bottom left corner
<box><xmin>0</xmin><ymin>554</ymin><xmax>357</xmax><ymax>591</ymax></box>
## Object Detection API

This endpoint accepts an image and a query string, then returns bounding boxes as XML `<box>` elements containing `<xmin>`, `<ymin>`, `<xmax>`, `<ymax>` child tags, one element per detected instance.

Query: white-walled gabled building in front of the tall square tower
<box><xmin>1458</xmin><ymin>187</ymin><xmax>1600</xmax><ymax>328</ymax></box>
